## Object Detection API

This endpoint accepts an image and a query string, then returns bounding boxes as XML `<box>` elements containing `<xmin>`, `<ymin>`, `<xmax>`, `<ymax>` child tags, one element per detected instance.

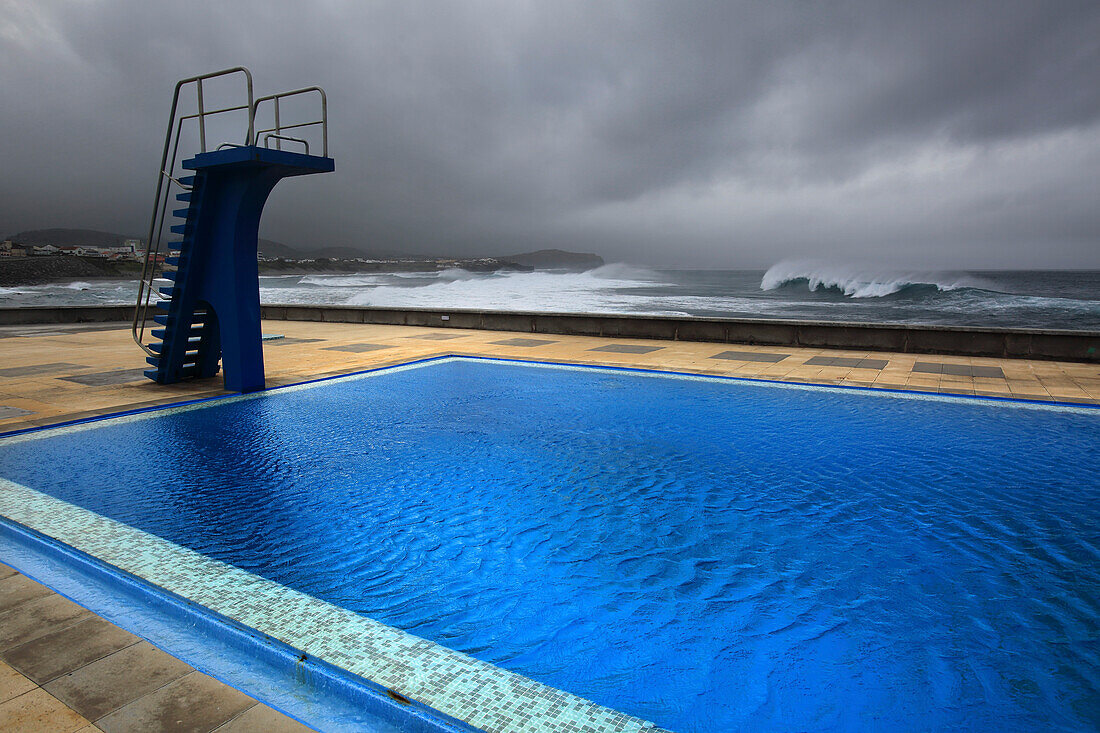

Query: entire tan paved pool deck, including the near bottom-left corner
<box><xmin>0</xmin><ymin>320</ymin><xmax>1100</xmax><ymax>733</ymax></box>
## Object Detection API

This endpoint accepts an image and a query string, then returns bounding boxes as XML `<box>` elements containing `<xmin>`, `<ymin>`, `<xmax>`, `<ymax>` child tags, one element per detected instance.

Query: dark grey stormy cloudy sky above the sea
<box><xmin>0</xmin><ymin>0</ymin><xmax>1100</xmax><ymax>267</ymax></box>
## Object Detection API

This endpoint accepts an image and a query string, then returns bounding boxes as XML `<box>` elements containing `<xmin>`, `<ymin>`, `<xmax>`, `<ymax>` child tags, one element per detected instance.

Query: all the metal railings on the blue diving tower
<box><xmin>131</xmin><ymin>66</ymin><xmax>329</xmax><ymax>357</ymax></box>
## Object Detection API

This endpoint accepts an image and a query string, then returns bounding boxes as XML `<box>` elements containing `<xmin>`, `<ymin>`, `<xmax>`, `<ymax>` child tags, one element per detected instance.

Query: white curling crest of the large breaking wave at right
<box><xmin>760</xmin><ymin>260</ymin><xmax>989</xmax><ymax>298</ymax></box>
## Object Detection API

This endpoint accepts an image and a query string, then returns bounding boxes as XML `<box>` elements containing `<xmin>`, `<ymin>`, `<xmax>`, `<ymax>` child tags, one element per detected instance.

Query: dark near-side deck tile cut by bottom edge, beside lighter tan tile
<box><xmin>94</xmin><ymin>671</ymin><xmax>256</xmax><ymax>733</ymax></box>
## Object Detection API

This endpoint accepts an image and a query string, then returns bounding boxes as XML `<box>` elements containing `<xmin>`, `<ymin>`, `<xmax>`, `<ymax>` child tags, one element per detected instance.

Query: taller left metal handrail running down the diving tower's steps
<box><xmin>130</xmin><ymin>66</ymin><xmax>253</xmax><ymax>357</ymax></box>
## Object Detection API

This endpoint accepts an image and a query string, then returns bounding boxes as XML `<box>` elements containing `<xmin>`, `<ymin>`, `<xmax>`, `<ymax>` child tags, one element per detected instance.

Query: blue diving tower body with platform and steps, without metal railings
<box><xmin>150</xmin><ymin>145</ymin><xmax>334</xmax><ymax>392</ymax></box>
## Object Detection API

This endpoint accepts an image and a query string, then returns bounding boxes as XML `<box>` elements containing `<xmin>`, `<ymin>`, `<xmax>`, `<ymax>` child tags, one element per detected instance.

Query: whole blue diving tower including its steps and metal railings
<box><xmin>132</xmin><ymin>67</ymin><xmax>334</xmax><ymax>392</ymax></box>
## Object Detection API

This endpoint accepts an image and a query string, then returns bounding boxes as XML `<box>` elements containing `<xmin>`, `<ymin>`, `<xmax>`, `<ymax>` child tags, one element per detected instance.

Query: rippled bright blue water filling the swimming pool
<box><xmin>0</xmin><ymin>360</ymin><xmax>1100</xmax><ymax>732</ymax></box>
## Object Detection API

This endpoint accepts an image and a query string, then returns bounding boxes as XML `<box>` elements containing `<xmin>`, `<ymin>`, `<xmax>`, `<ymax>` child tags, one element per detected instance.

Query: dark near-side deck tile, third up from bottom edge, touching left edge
<box><xmin>0</xmin><ymin>615</ymin><xmax>140</xmax><ymax>685</ymax></box>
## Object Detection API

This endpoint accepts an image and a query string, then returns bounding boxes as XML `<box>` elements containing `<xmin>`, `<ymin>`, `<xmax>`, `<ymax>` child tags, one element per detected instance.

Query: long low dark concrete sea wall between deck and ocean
<box><xmin>0</xmin><ymin>305</ymin><xmax>1100</xmax><ymax>362</ymax></box>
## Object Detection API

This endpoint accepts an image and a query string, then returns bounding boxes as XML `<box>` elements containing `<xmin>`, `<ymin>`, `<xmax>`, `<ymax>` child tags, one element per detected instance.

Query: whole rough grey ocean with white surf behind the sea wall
<box><xmin>0</xmin><ymin>262</ymin><xmax>1100</xmax><ymax>331</ymax></box>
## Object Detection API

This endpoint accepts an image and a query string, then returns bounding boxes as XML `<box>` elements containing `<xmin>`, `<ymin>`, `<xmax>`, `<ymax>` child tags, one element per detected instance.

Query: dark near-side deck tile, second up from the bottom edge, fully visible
<box><xmin>43</xmin><ymin>642</ymin><xmax>194</xmax><ymax>721</ymax></box>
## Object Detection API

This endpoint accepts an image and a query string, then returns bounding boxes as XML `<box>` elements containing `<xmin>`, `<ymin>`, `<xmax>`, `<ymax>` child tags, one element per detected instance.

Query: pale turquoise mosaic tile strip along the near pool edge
<box><xmin>0</xmin><ymin>479</ymin><xmax>659</xmax><ymax>733</ymax></box>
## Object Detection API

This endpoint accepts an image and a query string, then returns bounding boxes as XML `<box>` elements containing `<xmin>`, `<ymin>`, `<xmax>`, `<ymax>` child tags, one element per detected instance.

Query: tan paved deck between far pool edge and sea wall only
<box><xmin>0</xmin><ymin>320</ymin><xmax>1100</xmax><ymax>433</ymax></box>
